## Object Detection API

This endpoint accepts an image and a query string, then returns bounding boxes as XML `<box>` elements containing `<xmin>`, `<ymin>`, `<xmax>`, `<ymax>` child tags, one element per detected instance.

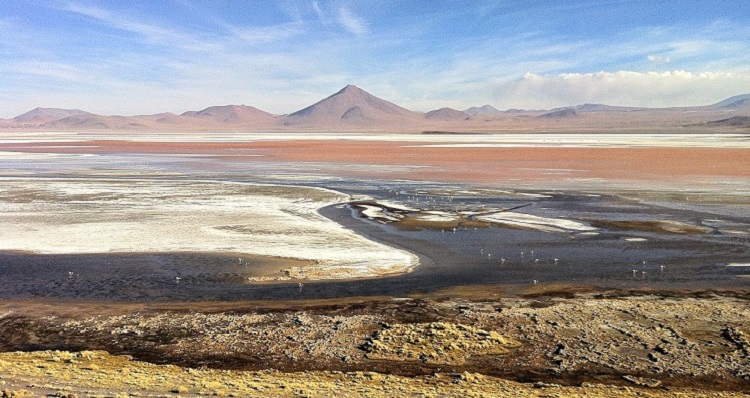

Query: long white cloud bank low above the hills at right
<box><xmin>496</xmin><ymin>70</ymin><xmax>750</xmax><ymax>108</ymax></box>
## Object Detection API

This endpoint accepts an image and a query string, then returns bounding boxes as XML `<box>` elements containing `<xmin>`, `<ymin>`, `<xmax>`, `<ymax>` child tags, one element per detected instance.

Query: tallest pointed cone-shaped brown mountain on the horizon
<box><xmin>282</xmin><ymin>85</ymin><xmax>421</xmax><ymax>128</ymax></box>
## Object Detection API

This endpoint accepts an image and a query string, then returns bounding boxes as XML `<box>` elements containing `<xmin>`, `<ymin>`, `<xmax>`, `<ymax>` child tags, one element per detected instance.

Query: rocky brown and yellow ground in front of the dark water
<box><xmin>0</xmin><ymin>288</ymin><xmax>750</xmax><ymax>397</ymax></box>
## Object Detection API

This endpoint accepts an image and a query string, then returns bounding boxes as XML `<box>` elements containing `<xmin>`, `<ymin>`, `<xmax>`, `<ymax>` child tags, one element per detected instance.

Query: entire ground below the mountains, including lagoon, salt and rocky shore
<box><xmin>0</xmin><ymin>89</ymin><xmax>750</xmax><ymax>397</ymax></box>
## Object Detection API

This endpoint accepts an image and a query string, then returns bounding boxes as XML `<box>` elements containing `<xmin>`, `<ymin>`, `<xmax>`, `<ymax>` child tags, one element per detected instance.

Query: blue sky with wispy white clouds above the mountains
<box><xmin>0</xmin><ymin>0</ymin><xmax>750</xmax><ymax>118</ymax></box>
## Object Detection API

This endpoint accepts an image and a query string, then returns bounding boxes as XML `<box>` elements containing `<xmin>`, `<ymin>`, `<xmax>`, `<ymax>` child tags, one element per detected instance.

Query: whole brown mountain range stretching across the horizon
<box><xmin>0</xmin><ymin>85</ymin><xmax>750</xmax><ymax>131</ymax></box>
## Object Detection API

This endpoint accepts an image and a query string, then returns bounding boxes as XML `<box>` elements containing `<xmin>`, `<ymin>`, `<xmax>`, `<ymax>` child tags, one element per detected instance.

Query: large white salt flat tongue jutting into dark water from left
<box><xmin>0</xmin><ymin>178</ymin><xmax>418</xmax><ymax>279</ymax></box>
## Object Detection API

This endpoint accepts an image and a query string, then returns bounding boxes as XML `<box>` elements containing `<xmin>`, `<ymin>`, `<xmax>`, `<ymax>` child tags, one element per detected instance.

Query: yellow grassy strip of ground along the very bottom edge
<box><xmin>0</xmin><ymin>351</ymin><xmax>743</xmax><ymax>398</ymax></box>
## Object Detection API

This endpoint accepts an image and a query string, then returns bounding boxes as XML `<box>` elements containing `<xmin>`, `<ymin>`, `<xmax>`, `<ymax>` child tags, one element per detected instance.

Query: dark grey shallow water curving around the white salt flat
<box><xmin>0</xmin><ymin>181</ymin><xmax>750</xmax><ymax>301</ymax></box>
